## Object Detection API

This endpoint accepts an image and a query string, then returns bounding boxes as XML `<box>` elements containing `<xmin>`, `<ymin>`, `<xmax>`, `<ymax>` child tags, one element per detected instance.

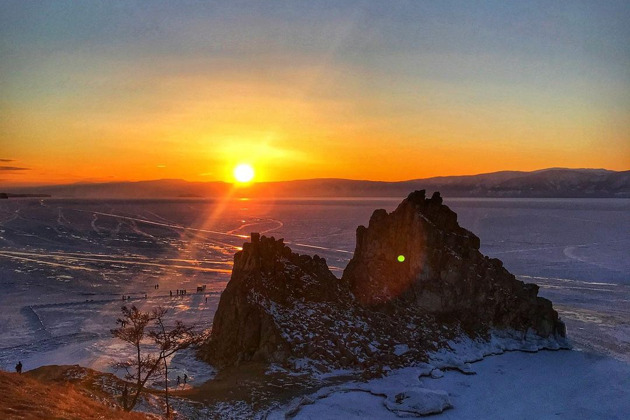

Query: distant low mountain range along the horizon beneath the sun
<box><xmin>3</xmin><ymin>168</ymin><xmax>630</xmax><ymax>198</ymax></box>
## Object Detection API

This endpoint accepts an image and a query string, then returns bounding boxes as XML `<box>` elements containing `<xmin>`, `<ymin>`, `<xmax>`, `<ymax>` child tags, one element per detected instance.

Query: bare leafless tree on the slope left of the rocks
<box><xmin>111</xmin><ymin>306</ymin><xmax>202</xmax><ymax>417</ymax></box>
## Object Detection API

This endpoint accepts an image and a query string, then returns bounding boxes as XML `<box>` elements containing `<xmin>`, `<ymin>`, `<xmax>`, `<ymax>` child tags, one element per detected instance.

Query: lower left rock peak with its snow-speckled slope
<box><xmin>200</xmin><ymin>234</ymin><xmax>438</xmax><ymax>369</ymax></box>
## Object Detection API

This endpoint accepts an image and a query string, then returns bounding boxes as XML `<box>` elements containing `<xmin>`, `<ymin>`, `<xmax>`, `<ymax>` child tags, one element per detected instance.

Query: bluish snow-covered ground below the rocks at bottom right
<box><xmin>282</xmin><ymin>350</ymin><xmax>630</xmax><ymax>420</ymax></box>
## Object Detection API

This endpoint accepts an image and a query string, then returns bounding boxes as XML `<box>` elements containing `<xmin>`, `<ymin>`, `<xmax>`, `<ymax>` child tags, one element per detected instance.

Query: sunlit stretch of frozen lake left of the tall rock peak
<box><xmin>0</xmin><ymin>199</ymin><xmax>382</xmax><ymax>377</ymax></box>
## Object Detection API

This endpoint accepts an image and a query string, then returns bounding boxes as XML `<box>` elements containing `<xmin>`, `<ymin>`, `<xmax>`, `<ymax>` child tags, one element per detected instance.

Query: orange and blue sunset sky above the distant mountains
<box><xmin>0</xmin><ymin>0</ymin><xmax>630</xmax><ymax>185</ymax></box>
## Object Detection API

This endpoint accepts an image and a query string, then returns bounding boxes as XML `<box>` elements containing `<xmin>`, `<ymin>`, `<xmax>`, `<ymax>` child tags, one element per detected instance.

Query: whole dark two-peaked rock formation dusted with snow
<box><xmin>200</xmin><ymin>191</ymin><xmax>565</xmax><ymax>369</ymax></box>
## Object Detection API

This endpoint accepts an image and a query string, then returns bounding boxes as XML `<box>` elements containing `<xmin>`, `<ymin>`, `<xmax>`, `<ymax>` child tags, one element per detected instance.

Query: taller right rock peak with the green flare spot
<box><xmin>343</xmin><ymin>190</ymin><xmax>564</xmax><ymax>337</ymax></box>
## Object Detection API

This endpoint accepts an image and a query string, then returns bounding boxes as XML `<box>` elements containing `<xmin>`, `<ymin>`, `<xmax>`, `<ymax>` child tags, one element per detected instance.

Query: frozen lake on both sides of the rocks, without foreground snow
<box><xmin>0</xmin><ymin>198</ymin><xmax>630</xmax><ymax>381</ymax></box>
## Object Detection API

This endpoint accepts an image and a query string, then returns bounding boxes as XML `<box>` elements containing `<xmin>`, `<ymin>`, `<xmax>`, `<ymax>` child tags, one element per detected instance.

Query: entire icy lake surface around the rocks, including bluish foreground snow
<box><xmin>0</xmin><ymin>198</ymin><xmax>630</xmax><ymax>419</ymax></box>
